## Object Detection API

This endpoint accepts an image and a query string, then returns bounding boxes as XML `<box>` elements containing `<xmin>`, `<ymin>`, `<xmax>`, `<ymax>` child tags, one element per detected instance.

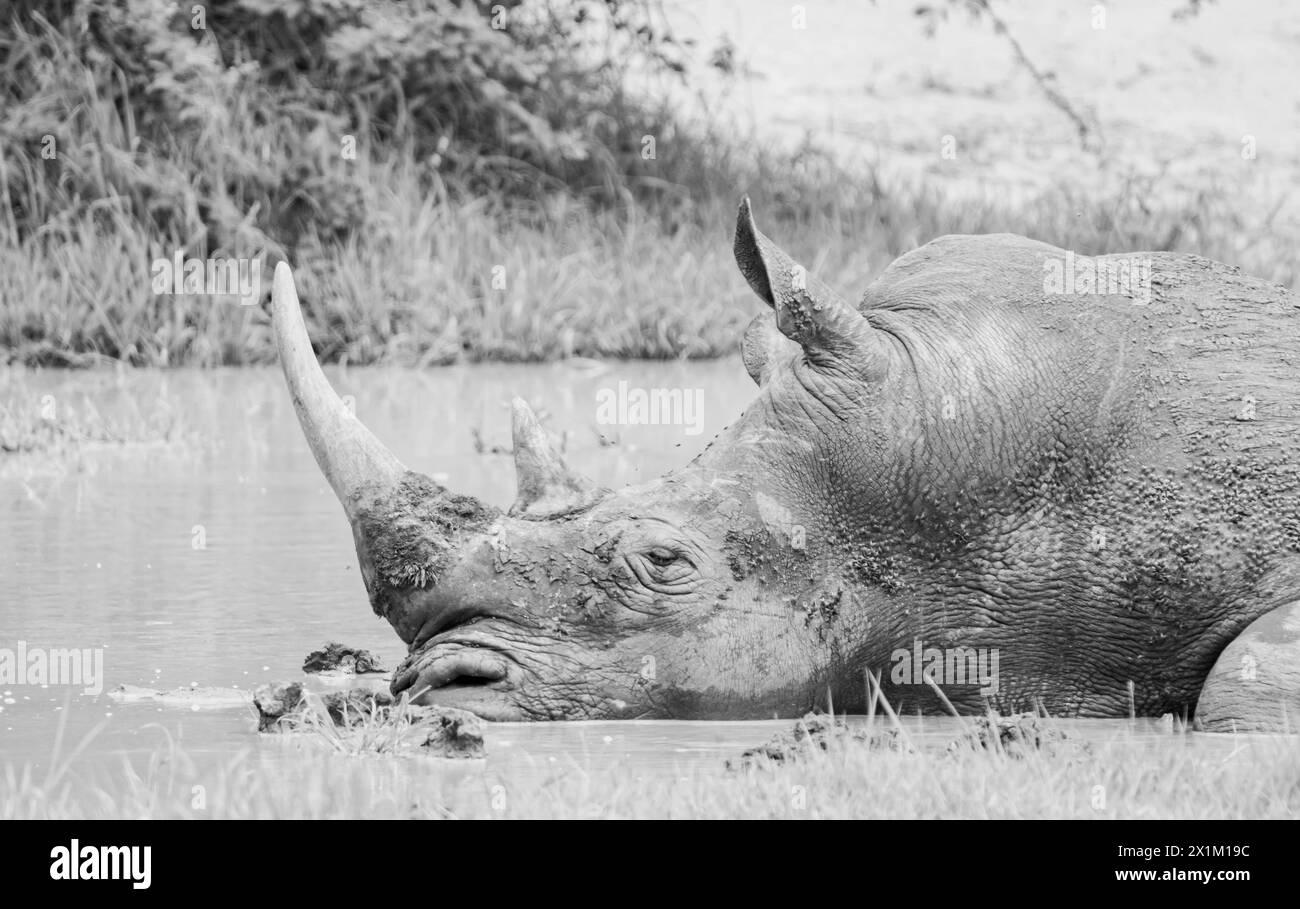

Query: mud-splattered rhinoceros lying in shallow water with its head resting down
<box><xmin>273</xmin><ymin>199</ymin><xmax>1300</xmax><ymax>730</ymax></box>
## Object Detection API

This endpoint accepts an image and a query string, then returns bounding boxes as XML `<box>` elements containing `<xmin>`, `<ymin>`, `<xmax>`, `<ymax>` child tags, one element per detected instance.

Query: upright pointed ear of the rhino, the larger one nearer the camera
<box><xmin>736</xmin><ymin>196</ymin><xmax>887</xmax><ymax>381</ymax></box>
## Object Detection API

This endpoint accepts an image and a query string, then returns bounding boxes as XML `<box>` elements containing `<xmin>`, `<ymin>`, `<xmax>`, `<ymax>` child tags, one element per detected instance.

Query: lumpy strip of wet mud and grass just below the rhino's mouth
<box><xmin>254</xmin><ymin>681</ymin><xmax>488</xmax><ymax>758</ymax></box>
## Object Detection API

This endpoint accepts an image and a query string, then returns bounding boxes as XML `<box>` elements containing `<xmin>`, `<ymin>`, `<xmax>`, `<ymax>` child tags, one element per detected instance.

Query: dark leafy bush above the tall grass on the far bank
<box><xmin>0</xmin><ymin>0</ymin><xmax>680</xmax><ymax>250</ymax></box>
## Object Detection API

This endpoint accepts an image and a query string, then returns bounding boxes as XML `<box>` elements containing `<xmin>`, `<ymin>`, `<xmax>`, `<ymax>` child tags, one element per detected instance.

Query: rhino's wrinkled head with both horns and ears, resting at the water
<box><xmin>273</xmin><ymin>200</ymin><xmax>946</xmax><ymax>719</ymax></box>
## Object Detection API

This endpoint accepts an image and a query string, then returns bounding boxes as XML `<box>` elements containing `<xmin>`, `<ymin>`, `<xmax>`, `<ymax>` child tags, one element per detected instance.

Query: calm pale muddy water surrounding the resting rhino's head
<box><xmin>0</xmin><ymin>360</ymin><xmax>1279</xmax><ymax>805</ymax></box>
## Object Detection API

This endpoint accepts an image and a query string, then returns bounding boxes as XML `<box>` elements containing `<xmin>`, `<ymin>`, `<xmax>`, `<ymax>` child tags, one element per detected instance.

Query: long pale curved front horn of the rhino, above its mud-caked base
<box><xmin>270</xmin><ymin>263</ymin><xmax>406</xmax><ymax>520</ymax></box>
